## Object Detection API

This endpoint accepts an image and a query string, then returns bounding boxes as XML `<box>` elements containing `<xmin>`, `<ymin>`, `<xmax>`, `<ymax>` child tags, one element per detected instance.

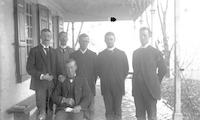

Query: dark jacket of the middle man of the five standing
<box><xmin>71</xmin><ymin>49</ymin><xmax>97</xmax><ymax>95</ymax></box>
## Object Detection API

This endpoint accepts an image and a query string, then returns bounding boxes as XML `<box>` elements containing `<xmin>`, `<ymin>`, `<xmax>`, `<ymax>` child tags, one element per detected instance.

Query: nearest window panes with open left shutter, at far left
<box><xmin>14</xmin><ymin>0</ymin><xmax>33</xmax><ymax>83</ymax></box>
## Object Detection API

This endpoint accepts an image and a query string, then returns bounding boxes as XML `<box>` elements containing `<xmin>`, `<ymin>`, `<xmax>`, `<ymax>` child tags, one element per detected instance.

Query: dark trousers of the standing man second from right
<box><xmin>103</xmin><ymin>90</ymin><xmax>122</xmax><ymax>120</ymax></box>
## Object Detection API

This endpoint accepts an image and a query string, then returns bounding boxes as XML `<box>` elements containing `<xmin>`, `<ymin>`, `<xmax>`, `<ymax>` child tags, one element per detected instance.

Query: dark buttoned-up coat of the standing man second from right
<box><xmin>98</xmin><ymin>48</ymin><xmax>129</xmax><ymax>95</ymax></box>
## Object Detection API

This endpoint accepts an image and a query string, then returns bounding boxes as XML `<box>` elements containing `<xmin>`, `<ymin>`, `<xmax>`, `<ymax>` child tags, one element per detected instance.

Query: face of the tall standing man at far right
<box><xmin>140</xmin><ymin>30</ymin><xmax>150</xmax><ymax>46</ymax></box>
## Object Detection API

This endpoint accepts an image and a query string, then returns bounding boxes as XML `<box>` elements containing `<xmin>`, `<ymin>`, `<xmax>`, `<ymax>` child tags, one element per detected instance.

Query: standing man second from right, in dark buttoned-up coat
<box><xmin>98</xmin><ymin>32</ymin><xmax>129</xmax><ymax>120</ymax></box>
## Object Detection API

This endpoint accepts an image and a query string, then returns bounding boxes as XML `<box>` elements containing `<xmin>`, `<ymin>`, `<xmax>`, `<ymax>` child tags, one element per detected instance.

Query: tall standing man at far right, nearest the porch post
<box><xmin>132</xmin><ymin>27</ymin><xmax>166</xmax><ymax>120</ymax></box>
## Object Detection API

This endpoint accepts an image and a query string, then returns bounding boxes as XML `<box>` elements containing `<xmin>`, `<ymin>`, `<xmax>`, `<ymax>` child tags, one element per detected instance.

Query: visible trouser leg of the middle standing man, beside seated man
<box><xmin>84</xmin><ymin>96</ymin><xmax>95</xmax><ymax>120</ymax></box>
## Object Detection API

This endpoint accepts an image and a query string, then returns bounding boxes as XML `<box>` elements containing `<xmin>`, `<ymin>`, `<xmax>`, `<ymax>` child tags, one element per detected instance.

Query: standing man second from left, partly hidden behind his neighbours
<box><xmin>56</xmin><ymin>32</ymin><xmax>74</xmax><ymax>82</ymax></box>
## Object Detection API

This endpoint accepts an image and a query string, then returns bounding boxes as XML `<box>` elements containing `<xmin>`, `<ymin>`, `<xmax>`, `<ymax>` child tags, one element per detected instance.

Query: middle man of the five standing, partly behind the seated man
<box><xmin>71</xmin><ymin>33</ymin><xmax>97</xmax><ymax>120</ymax></box>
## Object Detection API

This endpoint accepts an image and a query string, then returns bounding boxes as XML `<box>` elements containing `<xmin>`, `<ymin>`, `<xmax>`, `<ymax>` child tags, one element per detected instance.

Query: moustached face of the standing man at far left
<box><xmin>41</xmin><ymin>32</ymin><xmax>51</xmax><ymax>46</ymax></box>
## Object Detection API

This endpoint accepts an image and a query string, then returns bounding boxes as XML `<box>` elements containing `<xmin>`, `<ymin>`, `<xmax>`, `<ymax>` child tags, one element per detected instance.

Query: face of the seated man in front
<box><xmin>66</xmin><ymin>61</ymin><xmax>77</xmax><ymax>77</ymax></box>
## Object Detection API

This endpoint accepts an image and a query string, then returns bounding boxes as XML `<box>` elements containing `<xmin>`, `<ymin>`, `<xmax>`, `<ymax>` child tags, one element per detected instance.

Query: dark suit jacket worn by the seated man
<box><xmin>52</xmin><ymin>76</ymin><xmax>91</xmax><ymax>111</ymax></box>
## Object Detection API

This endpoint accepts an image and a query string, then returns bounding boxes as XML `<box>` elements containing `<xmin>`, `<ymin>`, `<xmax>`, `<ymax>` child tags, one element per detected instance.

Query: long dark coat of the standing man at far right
<box><xmin>132</xmin><ymin>46</ymin><xmax>166</xmax><ymax>99</ymax></box>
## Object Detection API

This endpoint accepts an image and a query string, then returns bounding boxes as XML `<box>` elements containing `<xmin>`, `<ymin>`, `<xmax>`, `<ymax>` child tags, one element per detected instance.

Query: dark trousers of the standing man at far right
<box><xmin>134</xmin><ymin>85</ymin><xmax>157</xmax><ymax>120</ymax></box>
